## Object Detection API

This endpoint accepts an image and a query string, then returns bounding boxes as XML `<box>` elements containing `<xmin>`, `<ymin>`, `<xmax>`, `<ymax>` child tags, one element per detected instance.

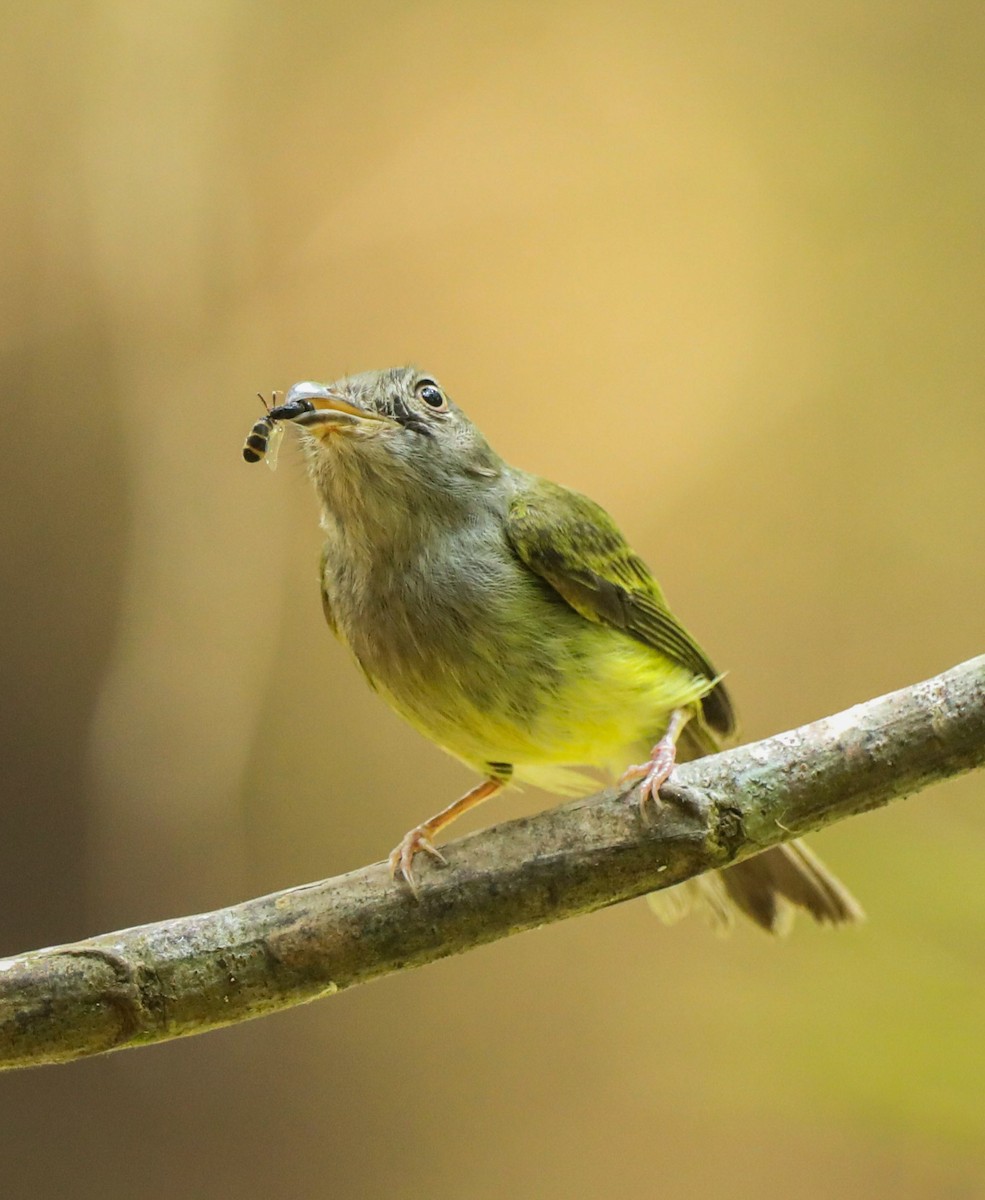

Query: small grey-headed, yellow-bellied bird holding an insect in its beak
<box><xmin>244</xmin><ymin>367</ymin><xmax>861</xmax><ymax>932</ymax></box>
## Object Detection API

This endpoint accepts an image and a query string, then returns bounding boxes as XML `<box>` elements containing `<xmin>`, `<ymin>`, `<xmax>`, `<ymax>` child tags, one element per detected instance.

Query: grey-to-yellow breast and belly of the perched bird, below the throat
<box><xmin>323</xmin><ymin>527</ymin><xmax>707</xmax><ymax>779</ymax></box>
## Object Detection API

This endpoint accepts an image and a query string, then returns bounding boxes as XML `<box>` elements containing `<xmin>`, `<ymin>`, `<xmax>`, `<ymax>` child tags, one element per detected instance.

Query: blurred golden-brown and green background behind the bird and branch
<box><xmin>0</xmin><ymin>0</ymin><xmax>985</xmax><ymax>1200</ymax></box>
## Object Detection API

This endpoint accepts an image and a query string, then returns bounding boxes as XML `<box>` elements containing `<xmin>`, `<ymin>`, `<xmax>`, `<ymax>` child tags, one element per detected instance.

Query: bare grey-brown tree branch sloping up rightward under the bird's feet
<box><xmin>0</xmin><ymin>655</ymin><xmax>985</xmax><ymax>1068</ymax></box>
